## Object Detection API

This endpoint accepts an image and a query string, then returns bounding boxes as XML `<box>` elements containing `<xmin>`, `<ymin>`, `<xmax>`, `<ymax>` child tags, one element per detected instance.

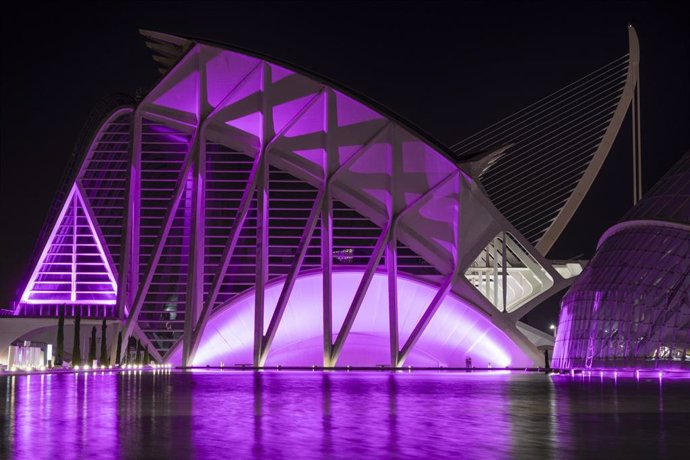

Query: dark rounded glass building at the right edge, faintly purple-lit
<box><xmin>552</xmin><ymin>152</ymin><xmax>690</xmax><ymax>369</ymax></box>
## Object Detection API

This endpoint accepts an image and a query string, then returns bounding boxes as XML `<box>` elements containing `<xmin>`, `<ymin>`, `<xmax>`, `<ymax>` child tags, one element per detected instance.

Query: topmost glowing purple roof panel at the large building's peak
<box><xmin>206</xmin><ymin>50</ymin><xmax>259</xmax><ymax>107</ymax></box>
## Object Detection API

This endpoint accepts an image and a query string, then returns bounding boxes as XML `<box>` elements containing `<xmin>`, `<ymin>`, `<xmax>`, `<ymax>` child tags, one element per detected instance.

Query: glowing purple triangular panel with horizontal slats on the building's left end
<box><xmin>21</xmin><ymin>184</ymin><xmax>117</xmax><ymax>305</ymax></box>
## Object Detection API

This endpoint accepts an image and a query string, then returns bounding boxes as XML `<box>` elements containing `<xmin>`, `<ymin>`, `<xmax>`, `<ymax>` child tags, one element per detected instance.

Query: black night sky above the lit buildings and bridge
<box><xmin>0</xmin><ymin>2</ymin><xmax>690</xmax><ymax>326</ymax></box>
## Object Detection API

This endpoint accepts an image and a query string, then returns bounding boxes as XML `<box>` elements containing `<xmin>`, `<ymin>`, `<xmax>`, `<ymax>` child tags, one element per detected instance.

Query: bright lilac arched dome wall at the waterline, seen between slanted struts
<box><xmin>170</xmin><ymin>271</ymin><xmax>531</xmax><ymax>367</ymax></box>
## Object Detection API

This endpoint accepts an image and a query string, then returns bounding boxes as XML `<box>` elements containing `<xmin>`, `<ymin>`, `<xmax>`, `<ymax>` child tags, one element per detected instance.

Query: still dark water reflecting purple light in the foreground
<box><xmin>0</xmin><ymin>371</ymin><xmax>690</xmax><ymax>459</ymax></box>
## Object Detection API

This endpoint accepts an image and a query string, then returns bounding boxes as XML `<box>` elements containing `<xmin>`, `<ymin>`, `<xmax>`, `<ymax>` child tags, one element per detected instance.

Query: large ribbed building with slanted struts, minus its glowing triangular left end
<box><xmin>14</xmin><ymin>28</ymin><xmax>620</xmax><ymax>367</ymax></box>
